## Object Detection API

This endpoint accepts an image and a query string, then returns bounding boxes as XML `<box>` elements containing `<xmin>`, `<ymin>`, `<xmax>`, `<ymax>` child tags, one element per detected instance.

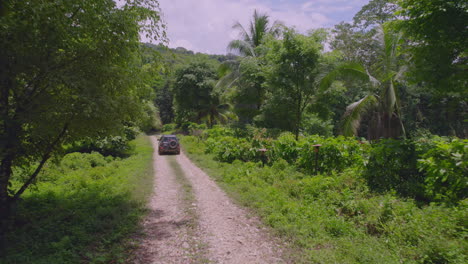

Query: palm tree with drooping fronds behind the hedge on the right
<box><xmin>320</xmin><ymin>26</ymin><xmax>406</xmax><ymax>140</ymax></box>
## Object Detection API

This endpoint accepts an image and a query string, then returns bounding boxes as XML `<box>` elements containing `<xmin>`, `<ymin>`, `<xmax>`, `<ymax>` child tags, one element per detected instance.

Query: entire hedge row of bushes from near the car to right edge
<box><xmin>199</xmin><ymin>127</ymin><xmax>467</xmax><ymax>203</ymax></box>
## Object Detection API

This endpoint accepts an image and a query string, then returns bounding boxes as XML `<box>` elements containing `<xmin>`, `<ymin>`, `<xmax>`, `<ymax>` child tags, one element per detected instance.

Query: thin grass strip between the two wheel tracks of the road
<box><xmin>168</xmin><ymin>156</ymin><xmax>209</xmax><ymax>263</ymax></box>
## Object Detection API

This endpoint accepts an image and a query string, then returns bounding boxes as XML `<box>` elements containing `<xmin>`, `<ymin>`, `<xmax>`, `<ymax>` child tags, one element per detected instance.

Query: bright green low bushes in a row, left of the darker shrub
<box><xmin>196</xmin><ymin>127</ymin><xmax>370</xmax><ymax>173</ymax></box>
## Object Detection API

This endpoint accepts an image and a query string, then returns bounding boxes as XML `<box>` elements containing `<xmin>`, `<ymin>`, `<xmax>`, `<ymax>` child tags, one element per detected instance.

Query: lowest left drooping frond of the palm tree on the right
<box><xmin>341</xmin><ymin>95</ymin><xmax>378</xmax><ymax>136</ymax></box>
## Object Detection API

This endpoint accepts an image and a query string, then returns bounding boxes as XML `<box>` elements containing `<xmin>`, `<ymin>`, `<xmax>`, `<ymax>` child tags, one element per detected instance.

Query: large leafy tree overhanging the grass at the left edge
<box><xmin>0</xmin><ymin>0</ymin><xmax>164</xmax><ymax>217</ymax></box>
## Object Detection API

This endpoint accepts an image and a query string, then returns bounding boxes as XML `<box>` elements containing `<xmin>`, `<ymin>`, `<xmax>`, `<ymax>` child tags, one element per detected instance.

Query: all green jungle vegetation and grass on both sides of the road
<box><xmin>0</xmin><ymin>0</ymin><xmax>468</xmax><ymax>263</ymax></box>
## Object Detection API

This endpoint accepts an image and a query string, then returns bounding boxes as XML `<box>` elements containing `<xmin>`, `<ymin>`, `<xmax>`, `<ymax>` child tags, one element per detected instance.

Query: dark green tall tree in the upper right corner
<box><xmin>399</xmin><ymin>0</ymin><xmax>468</xmax><ymax>137</ymax></box>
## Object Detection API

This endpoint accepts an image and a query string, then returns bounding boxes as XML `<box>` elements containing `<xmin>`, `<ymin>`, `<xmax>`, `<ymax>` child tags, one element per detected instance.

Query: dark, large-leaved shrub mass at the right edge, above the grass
<box><xmin>364</xmin><ymin>138</ymin><xmax>467</xmax><ymax>203</ymax></box>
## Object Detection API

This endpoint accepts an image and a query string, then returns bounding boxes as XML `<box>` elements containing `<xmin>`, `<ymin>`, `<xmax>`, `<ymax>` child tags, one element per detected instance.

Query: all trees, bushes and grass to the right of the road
<box><xmin>156</xmin><ymin>0</ymin><xmax>468</xmax><ymax>263</ymax></box>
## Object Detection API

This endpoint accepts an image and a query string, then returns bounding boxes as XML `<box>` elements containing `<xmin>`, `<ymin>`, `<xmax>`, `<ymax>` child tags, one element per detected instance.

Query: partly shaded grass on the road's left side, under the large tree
<box><xmin>0</xmin><ymin>136</ymin><xmax>153</xmax><ymax>264</ymax></box>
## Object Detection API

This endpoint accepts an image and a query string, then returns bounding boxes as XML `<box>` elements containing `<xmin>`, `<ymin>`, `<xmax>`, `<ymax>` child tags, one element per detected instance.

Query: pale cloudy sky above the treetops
<box><xmin>159</xmin><ymin>0</ymin><xmax>369</xmax><ymax>54</ymax></box>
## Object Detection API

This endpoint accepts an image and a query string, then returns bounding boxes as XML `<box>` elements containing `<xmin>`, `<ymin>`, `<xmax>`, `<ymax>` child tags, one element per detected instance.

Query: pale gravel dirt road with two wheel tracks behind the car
<box><xmin>133</xmin><ymin>137</ymin><xmax>284</xmax><ymax>264</ymax></box>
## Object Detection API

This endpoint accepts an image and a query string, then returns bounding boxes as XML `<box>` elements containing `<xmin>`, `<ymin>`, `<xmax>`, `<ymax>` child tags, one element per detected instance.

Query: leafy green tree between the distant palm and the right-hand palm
<box><xmin>264</xmin><ymin>29</ymin><xmax>324</xmax><ymax>138</ymax></box>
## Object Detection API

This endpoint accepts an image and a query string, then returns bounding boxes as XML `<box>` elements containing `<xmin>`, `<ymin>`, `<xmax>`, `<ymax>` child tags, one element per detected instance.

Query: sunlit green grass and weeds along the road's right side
<box><xmin>181</xmin><ymin>136</ymin><xmax>468</xmax><ymax>264</ymax></box>
